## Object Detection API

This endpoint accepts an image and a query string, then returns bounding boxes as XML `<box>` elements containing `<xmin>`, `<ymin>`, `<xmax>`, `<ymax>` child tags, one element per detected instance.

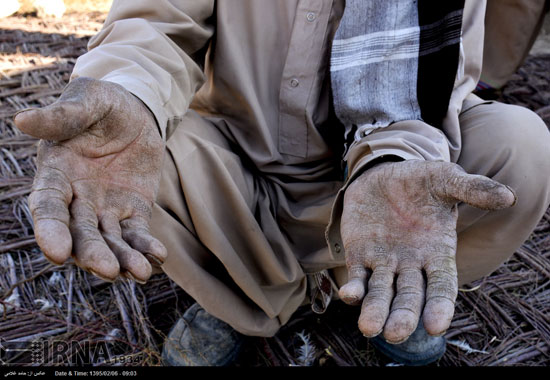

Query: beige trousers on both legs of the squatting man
<box><xmin>152</xmin><ymin>101</ymin><xmax>550</xmax><ymax>336</ymax></box>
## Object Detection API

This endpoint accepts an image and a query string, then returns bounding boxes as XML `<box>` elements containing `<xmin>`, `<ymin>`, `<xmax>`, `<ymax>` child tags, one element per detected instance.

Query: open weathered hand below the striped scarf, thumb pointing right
<box><xmin>340</xmin><ymin>160</ymin><xmax>516</xmax><ymax>343</ymax></box>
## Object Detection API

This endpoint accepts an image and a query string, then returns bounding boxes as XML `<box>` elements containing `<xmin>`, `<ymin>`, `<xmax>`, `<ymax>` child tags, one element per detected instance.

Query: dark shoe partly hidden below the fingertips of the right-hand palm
<box><xmin>370</xmin><ymin>321</ymin><xmax>446</xmax><ymax>366</ymax></box>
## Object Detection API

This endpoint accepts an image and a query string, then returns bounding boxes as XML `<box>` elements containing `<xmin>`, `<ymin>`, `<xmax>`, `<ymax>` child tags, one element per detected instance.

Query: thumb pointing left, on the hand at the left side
<box><xmin>14</xmin><ymin>78</ymin><xmax>109</xmax><ymax>141</ymax></box>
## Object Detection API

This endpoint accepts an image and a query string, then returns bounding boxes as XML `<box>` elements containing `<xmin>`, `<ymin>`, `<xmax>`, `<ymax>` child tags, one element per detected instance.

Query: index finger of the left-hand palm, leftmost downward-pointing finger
<box><xmin>28</xmin><ymin>167</ymin><xmax>73</xmax><ymax>265</ymax></box>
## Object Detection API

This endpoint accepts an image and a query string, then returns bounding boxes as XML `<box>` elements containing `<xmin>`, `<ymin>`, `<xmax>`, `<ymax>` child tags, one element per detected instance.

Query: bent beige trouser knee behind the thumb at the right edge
<box><xmin>457</xmin><ymin>103</ymin><xmax>550</xmax><ymax>283</ymax></box>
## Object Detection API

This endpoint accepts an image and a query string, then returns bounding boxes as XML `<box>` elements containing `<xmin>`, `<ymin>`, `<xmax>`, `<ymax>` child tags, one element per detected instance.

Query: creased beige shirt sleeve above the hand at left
<box><xmin>72</xmin><ymin>0</ymin><xmax>214</xmax><ymax>138</ymax></box>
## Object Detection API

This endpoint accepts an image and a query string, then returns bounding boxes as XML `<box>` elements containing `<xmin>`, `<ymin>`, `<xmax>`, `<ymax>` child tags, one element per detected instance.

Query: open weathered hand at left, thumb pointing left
<box><xmin>15</xmin><ymin>78</ymin><xmax>167</xmax><ymax>282</ymax></box>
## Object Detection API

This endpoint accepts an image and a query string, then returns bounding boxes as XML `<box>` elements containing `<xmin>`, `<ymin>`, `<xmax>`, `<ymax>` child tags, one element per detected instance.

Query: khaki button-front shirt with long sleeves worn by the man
<box><xmin>73</xmin><ymin>0</ymin><xmax>485</xmax><ymax>266</ymax></box>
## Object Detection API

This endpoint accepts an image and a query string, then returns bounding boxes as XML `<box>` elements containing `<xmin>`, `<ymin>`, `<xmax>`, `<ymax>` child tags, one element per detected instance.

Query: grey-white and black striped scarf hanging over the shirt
<box><xmin>330</xmin><ymin>0</ymin><xmax>464</xmax><ymax>153</ymax></box>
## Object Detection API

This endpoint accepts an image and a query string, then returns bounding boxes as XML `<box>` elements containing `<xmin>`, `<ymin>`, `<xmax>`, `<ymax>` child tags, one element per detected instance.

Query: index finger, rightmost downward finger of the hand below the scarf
<box><xmin>423</xmin><ymin>252</ymin><xmax>458</xmax><ymax>336</ymax></box>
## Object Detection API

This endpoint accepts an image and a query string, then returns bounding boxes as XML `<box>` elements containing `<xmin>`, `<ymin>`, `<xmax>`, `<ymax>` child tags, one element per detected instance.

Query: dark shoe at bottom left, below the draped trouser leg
<box><xmin>162</xmin><ymin>303</ymin><xmax>244</xmax><ymax>366</ymax></box>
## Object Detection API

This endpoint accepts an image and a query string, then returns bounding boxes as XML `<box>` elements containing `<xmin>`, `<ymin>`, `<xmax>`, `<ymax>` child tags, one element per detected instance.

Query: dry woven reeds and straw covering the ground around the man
<box><xmin>0</xmin><ymin>12</ymin><xmax>550</xmax><ymax>366</ymax></box>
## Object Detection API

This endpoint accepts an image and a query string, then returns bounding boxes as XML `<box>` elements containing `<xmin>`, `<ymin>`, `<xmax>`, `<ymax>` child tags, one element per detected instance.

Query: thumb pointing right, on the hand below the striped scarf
<box><xmin>436</xmin><ymin>165</ymin><xmax>517</xmax><ymax>210</ymax></box>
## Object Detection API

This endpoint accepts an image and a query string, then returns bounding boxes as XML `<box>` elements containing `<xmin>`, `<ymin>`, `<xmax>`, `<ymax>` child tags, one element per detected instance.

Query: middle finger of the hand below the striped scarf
<box><xmin>384</xmin><ymin>269</ymin><xmax>424</xmax><ymax>344</ymax></box>
